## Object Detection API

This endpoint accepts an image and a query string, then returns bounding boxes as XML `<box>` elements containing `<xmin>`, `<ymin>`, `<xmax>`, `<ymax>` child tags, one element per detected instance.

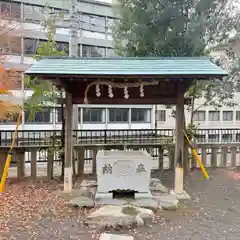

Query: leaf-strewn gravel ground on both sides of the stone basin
<box><xmin>0</xmin><ymin>169</ymin><xmax>240</xmax><ymax>240</ymax></box>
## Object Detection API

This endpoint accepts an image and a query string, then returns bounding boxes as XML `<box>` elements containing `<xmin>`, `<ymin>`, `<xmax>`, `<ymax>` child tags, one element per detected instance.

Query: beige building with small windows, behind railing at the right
<box><xmin>153</xmin><ymin>92</ymin><xmax>240</xmax><ymax>142</ymax></box>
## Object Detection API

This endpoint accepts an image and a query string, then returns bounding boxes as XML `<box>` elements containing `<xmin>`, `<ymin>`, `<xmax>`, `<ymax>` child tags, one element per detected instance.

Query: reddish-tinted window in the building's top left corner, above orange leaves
<box><xmin>0</xmin><ymin>1</ymin><xmax>21</xmax><ymax>19</ymax></box>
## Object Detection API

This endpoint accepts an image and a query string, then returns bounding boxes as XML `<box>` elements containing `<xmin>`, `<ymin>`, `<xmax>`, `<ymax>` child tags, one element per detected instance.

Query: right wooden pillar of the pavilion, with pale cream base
<box><xmin>174</xmin><ymin>88</ymin><xmax>184</xmax><ymax>193</ymax></box>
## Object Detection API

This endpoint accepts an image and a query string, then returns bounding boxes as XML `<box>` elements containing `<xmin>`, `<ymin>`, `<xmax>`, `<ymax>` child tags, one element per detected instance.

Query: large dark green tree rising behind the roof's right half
<box><xmin>113</xmin><ymin>0</ymin><xmax>240</xmax><ymax>122</ymax></box>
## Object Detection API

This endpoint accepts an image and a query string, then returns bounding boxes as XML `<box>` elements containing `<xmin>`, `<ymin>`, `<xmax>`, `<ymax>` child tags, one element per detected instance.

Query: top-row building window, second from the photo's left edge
<box><xmin>23</xmin><ymin>4</ymin><xmax>44</xmax><ymax>23</ymax></box>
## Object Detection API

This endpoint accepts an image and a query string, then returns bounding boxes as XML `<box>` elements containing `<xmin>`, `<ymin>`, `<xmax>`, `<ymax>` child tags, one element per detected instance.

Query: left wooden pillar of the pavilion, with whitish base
<box><xmin>64</xmin><ymin>89</ymin><xmax>73</xmax><ymax>193</ymax></box>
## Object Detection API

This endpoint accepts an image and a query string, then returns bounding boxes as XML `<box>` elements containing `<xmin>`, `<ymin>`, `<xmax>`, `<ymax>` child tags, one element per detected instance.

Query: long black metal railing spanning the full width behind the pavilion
<box><xmin>0</xmin><ymin>129</ymin><xmax>240</xmax><ymax>147</ymax></box>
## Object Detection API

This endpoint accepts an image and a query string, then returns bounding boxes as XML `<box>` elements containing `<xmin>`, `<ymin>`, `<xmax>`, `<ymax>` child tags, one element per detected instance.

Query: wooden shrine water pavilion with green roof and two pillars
<box><xmin>25</xmin><ymin>57</ymin><xmax>228</xmax><ymax>197</ymax></box>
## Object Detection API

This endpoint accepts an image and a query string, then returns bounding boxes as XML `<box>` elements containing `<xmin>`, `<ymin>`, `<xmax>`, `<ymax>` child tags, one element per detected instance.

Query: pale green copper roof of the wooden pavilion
<box><xmin>25</xmin><ymin>57</ymin><xmax>228</xmax><ymax>77</ymax></box>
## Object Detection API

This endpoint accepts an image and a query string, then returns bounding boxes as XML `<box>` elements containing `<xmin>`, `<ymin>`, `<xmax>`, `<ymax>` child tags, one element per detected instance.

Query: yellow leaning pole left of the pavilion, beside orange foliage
<box><xmin>0</xmin><ymin>111</ymin><xmax>22</xmax><ymax>193</ymax></box>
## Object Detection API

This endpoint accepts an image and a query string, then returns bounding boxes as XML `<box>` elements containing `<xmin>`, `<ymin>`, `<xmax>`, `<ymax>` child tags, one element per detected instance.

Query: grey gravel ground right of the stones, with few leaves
<box><xmin>117</xmin><ymin>169</ymin><xmax>240</xmax><ymax>240</ymax></box>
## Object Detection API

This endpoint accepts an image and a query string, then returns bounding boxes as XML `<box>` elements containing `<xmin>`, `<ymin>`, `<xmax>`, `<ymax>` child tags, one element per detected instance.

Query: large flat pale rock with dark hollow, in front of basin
<box><xmin>84</xmin><ymin>205</ymin><xmax>154</xmax><ymax>230</ymax></box>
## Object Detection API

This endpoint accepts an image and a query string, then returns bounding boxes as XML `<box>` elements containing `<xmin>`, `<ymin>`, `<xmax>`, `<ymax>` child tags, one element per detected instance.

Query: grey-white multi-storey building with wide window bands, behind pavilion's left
<box><xmin>0</xmin><ymin>0</ymin><xmax>154</xmax><ymax>130</ymax></box>
